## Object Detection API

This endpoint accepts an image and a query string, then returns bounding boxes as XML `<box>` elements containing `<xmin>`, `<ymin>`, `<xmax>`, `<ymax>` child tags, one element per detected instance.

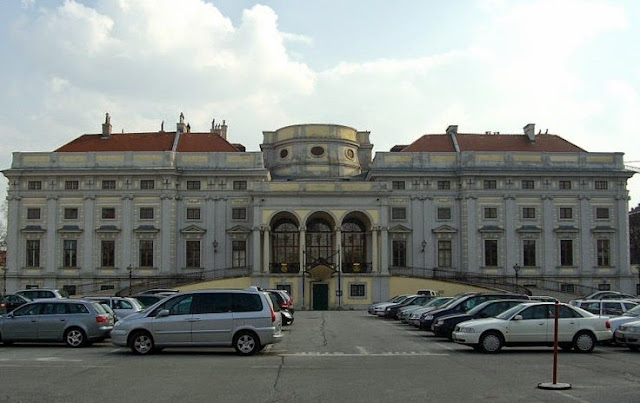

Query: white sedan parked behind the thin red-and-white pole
<box><xmin>453</xmin><ymin>302</ymin><xmax>613</xmax><ymax>353</ymax></box>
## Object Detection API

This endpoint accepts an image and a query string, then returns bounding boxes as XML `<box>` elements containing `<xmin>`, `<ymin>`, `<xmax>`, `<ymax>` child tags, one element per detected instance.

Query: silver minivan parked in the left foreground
<box><xmin>111</xmin><ymin>287</ymin><xmax>282</xmax><ymax>355</ymax></box>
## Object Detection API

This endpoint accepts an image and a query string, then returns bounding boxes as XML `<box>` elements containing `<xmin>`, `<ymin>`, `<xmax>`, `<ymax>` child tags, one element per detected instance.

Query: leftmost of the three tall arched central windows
<box><xmin>271</xmin><ymin>219</ymin><xmax>300</xmax><ymax>272</ymax></box>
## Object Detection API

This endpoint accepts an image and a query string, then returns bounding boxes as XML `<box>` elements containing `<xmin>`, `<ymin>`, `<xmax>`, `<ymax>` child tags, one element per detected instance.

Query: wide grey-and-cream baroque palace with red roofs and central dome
<box><xmin>3</xmin><ymin>114</ymin><xmax>635</xmax><ymax>309</ymax></box>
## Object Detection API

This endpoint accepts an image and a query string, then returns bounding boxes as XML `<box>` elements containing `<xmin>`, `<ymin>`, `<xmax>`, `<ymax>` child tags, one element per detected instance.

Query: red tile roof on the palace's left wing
<box><xmin>55</xmin><ymin>132</ymin><xmax>238</xmax><ymax>152</ymax></box>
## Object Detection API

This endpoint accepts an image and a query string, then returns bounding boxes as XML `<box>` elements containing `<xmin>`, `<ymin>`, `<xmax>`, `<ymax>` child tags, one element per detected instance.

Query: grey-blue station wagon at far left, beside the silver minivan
<box><xmin>0</xmin><ymin>299</ymin><xmax>113</xmax><ymax>347</ymax></box>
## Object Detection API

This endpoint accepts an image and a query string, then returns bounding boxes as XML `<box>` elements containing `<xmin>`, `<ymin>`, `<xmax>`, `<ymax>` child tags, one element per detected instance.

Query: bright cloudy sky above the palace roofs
<box><xmin>0</xmin><ymin>0</ymin><xmax>640</xmax><ymax>218</ymax></box>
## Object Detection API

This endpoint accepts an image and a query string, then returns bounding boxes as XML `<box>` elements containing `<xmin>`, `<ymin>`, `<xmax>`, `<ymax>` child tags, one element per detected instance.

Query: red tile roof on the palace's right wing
<box><xmin>402</xmin><ymin>134</ymin><xmax>585</xmax><ymax>152</ymax></box>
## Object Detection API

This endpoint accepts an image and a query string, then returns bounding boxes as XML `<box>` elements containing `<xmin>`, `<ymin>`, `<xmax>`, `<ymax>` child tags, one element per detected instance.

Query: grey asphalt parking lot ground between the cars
<box><xmin>0</xmin><ymin>311</ymin><xmax>640</xmax><ymax>403</ymax></box>
